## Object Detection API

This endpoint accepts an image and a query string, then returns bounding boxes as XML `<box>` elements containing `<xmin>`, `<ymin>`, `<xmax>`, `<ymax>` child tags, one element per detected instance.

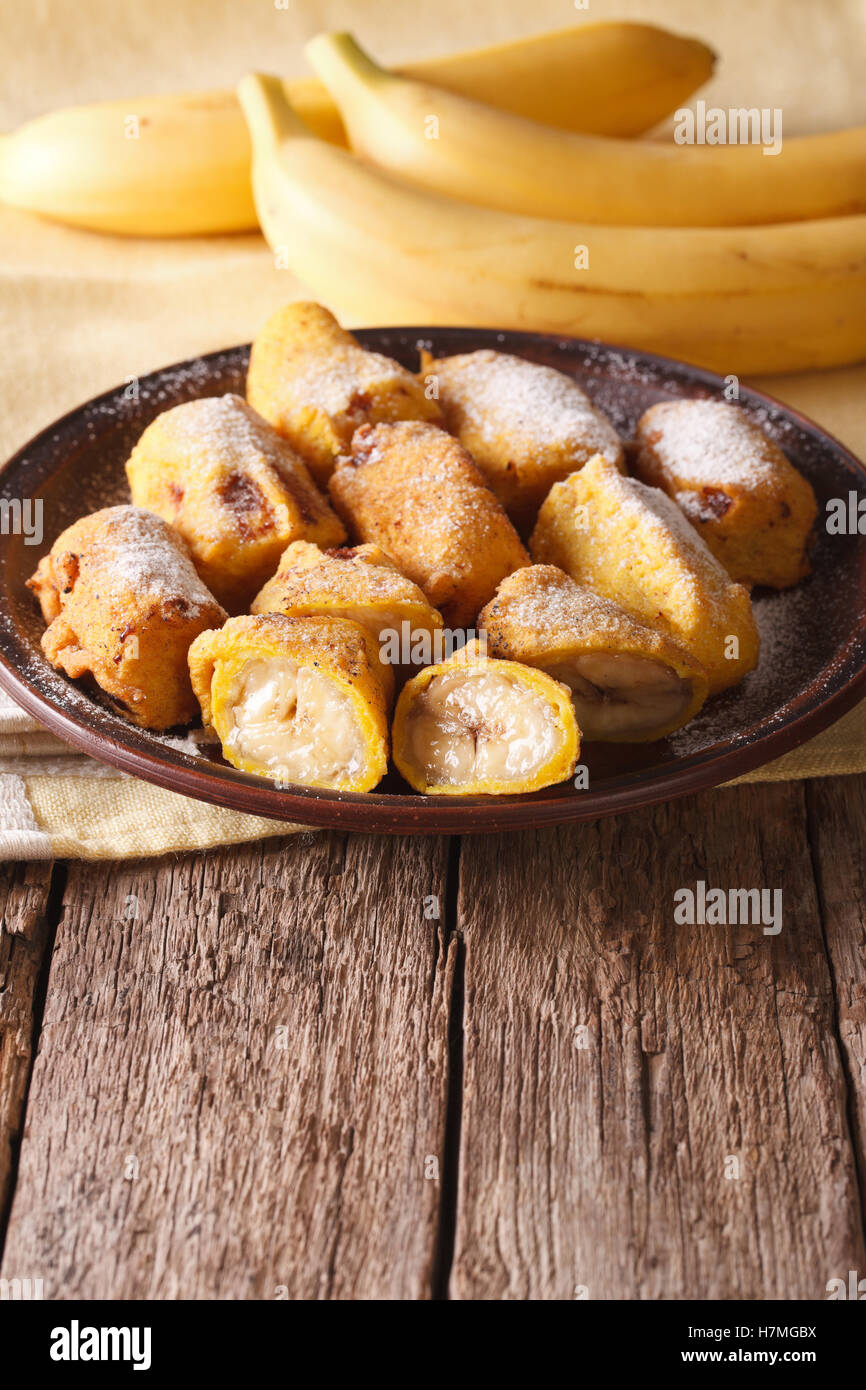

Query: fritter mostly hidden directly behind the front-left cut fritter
<box><xmin>252</xmin><ymin>541</ymin><xmax>442</xmax><ymax>701</ymax></box>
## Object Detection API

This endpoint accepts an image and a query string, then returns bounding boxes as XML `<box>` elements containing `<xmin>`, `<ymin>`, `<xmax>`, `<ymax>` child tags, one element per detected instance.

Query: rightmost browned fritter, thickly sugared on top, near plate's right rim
<box><xmin>634</xmin><ymin>400</ymin><xmax>817</xmax><ymax>589</ymax></box>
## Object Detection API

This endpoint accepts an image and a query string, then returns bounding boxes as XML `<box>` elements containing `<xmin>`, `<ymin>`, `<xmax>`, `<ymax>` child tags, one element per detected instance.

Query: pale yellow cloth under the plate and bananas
<box><xmin>0</xmin><ymin>0</ymin><xmax>866</xmax><ymax>859</ymax></box>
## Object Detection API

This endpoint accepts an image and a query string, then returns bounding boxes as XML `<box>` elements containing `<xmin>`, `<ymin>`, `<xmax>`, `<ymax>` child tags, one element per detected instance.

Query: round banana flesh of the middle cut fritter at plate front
<box><xmin>409</xmin><ymin>671</ymin><xmax>559</xmax><ymax>787</ymax></box>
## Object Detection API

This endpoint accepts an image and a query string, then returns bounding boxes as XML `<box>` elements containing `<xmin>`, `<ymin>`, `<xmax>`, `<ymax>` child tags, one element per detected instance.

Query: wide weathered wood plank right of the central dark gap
<box><xmin>452</xmin><ymin>784</ymin><xmax>866</xmax><ymax>1298</ymax></box>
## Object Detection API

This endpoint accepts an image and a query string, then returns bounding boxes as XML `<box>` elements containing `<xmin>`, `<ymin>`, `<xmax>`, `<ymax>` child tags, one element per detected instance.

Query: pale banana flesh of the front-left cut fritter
<box><xmin>225</xmin><ymin>657</ymin><xmax>364</xmax><ymax>787</ymax></box>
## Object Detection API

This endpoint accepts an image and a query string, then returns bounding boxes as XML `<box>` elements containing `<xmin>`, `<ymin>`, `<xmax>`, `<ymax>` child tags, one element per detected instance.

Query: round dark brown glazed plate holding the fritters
<box><xmin>0</xmin><ymin>328</ymin><xmax>866</xmax><ymax>834</ymax></box>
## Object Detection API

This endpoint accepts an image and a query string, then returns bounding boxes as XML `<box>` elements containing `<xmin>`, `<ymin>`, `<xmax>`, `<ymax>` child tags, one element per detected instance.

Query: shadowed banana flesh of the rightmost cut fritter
<box><xmin>545</xmin><ymin>652</ymin><xmax>692</xmax><ymax>742</ymax></box>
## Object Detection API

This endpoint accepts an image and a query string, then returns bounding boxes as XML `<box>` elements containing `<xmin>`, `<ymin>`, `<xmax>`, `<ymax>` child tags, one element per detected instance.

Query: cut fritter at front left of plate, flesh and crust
<box><xmin>189</xmin><ymin>613</ymin><xmax>388</xmax><ymax>791</ymax></box>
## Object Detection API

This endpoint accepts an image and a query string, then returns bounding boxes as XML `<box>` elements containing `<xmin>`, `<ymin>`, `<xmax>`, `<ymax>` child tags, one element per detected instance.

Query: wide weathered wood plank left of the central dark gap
<box><xmin>3</xmin><ymin>835</ymin><xmax>453</xmax><ymax>1298</ymax></box>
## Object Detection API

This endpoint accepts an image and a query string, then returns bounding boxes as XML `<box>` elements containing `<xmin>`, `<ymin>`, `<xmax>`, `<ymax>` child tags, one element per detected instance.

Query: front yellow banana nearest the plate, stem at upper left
<box><xmin>238</xmin><ymin>75</ymin><xmax>866</xmax><ymax>374</ymax></box>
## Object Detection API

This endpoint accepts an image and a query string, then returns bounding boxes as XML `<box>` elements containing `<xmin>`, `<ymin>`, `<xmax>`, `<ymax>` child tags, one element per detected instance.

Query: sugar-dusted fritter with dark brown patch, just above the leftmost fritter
<box><xmin>126</xmin><ymin>395</ymin><xmax>346</xmax><ymax>613</ymax></box>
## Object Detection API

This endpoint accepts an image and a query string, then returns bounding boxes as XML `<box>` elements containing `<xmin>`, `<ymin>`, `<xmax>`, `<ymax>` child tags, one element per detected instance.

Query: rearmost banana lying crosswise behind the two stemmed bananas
<box><xmin>0</xmin><ymin>24</ymin><xmax>713</xmax><ymax>236</ymax></box>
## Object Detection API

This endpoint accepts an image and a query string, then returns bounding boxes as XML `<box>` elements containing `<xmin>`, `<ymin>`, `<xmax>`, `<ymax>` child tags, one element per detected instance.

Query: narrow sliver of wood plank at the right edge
<box><xmin>806</xmin><ymin>776</ymin><xmax>866</xmax><ymax>1223</ymax></box>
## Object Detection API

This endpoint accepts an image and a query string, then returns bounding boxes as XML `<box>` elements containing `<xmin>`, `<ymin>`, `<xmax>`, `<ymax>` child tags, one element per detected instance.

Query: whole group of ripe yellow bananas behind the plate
<box><xmin>0</xmin><ymin>24</ymin><xmax>866</xmax><ymax>374</ymax></box>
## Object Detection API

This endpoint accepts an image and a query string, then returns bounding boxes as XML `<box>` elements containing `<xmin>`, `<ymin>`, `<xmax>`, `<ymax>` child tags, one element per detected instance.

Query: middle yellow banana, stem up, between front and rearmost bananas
<box><xmin>306</xmin><ymin>33</ymin><xmax>866</xmax><ymax>227</ymax></box>
